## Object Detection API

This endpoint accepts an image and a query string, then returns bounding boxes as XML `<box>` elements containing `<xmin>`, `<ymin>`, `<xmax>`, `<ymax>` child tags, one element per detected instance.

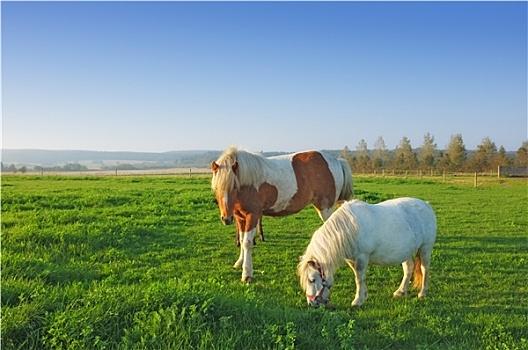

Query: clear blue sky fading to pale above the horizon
<box><xmin>1</xmin><ymin>1</ymin><xmax>528</xmax><ymax>152</ymax></box>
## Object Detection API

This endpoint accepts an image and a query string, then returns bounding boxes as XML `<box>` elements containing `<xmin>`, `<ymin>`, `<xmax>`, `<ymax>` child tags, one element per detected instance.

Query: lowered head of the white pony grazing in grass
<box><xmin>298</xmin><ymin>257</ymin><xmax>334</xmax><ymax>307</ymax></box>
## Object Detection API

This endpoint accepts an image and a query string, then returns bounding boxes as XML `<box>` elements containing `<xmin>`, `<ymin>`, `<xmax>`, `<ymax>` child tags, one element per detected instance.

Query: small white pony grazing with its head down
<box><xmin>297</xmin><ymin>198</ymin><xmax>436</xmax><ymax>307</ymax></box>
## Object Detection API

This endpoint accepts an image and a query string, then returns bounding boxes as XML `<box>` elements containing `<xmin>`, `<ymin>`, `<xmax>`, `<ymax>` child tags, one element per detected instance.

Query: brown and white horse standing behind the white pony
<box><xmin>211</xmin><ymin>147</ymin><xmax>353</xmax><ymax>282</ymax></box>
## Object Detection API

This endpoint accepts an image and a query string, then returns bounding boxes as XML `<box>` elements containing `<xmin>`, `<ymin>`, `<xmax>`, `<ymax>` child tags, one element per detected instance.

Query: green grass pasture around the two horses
<box><xmin>1</xmin><ymin>176</ymin><xmax>528</xmax><ymax>349</ymax></box>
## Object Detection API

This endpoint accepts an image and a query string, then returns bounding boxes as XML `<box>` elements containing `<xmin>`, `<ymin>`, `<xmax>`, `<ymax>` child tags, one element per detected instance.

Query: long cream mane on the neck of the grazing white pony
<box><xmin>297</xmin><ymin>200</ymin><xmax>359</xmax><ymax>289</ymax></box>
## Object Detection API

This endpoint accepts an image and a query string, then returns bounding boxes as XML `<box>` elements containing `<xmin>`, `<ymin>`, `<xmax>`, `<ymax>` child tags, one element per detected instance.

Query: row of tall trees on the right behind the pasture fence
<box><xmin>339</xmin><ymin>133</ymin><xmax>528</xmax><ymax>173</ymax></box>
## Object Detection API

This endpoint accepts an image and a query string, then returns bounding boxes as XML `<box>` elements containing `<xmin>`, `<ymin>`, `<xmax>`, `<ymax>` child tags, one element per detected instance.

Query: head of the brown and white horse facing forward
<box><xmin>211</xmin><ymin>159</ymin><xmax>240</xmax><ymax>225</ymax></box>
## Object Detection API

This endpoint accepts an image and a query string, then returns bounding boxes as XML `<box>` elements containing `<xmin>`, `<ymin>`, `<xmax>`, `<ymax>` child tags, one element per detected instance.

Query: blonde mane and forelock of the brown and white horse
<box><xmin>211</xmin><ymin>146</ymin><xmax>271</xmax><ymax>191</ymax></box>
